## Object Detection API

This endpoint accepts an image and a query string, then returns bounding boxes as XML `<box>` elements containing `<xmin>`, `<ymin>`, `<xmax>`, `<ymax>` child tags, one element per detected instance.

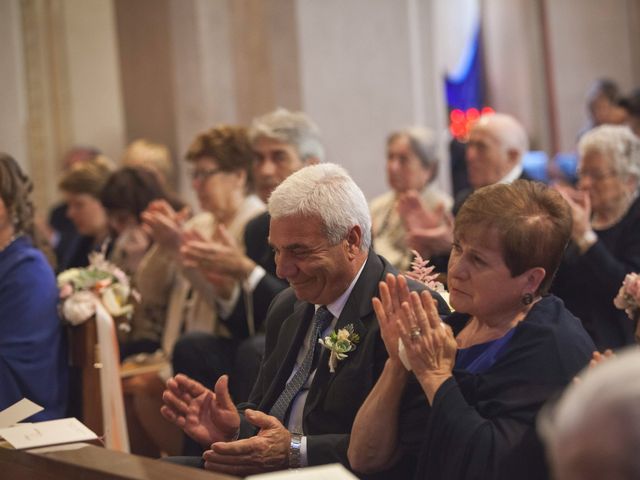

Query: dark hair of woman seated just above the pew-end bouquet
<box><xmin>100</xmin><ymin>167</ymin><xmax>168</xmax><ymax>221</ymax></box>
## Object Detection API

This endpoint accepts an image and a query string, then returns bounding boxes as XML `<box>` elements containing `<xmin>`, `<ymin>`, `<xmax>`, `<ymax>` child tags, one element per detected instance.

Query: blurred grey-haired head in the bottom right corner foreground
<box><xmin>538</xmin><ymin>348</ymin><xmax>640</xmax><ymax>480</ymax></box>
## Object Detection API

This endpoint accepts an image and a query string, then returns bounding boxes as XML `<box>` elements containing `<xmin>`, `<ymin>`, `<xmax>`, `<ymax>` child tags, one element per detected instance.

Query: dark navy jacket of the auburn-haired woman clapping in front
<box><xmin>413</xmin><ymin>296</ymin><xmax>594</xmax><ymax>480</ymax></box>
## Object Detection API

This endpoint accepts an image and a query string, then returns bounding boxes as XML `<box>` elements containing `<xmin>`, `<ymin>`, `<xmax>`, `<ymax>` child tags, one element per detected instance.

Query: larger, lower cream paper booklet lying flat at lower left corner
<box><xmin>0</xmin><ymin>418</ymin><xmax>98</xmax><ymax>450</ymax></box>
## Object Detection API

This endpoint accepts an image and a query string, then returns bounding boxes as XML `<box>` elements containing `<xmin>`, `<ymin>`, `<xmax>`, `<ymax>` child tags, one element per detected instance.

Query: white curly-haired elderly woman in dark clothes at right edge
<box><xmin>552</xmin><ymin>125</ymin><xmax>640</xmax><ymax>350</ymax></box>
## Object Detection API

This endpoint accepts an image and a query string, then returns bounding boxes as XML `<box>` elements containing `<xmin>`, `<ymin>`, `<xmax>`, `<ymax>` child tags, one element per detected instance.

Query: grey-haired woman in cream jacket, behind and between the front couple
<box><xmin>370</xmin><ymin>127</ymin><xmax>453</xmax><ymax>270</ymax></box>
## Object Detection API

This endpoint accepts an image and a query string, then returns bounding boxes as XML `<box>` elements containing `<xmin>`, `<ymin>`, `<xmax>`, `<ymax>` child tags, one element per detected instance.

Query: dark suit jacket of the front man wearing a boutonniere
<box><xmin>238</xmin><ymin>251</ymin><xmax>449</xmax><ymax>472</ymax></box>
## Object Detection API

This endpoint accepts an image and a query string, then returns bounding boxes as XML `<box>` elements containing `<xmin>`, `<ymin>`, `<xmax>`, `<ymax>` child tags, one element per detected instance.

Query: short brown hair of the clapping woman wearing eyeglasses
<box><xmin>186</xmin><ymin>125</ymin><xmax>253</xmax><ymax>187</ymax></box>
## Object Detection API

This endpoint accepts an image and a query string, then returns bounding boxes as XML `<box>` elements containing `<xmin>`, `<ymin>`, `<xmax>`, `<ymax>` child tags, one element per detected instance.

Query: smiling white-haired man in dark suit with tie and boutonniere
<box><xmin>162</xmin><ymin>164</ymin><xmax>448</xmax><ymax>476</ymax></box>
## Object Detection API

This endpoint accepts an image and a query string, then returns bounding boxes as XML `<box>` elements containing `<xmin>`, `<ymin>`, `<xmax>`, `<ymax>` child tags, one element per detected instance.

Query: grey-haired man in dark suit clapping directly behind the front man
<box><xmin>173</xmin><ymin>108</ymin><xmax>324</xmax><ymax>404</ymax></box>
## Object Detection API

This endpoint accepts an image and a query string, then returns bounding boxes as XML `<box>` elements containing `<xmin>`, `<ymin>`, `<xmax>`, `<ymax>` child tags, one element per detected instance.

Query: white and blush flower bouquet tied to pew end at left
<box><xmin>58</xmin><ymin>252</ymin><xmax>139</xmax><ymax>328</ymax></box>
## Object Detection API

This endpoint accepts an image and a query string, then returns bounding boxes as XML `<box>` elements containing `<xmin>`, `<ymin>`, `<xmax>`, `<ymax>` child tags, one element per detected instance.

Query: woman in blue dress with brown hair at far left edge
<box><xmin>0</xmin><ymin>154</ymin><xmax>68</xmax><ymax>420</ymax></box>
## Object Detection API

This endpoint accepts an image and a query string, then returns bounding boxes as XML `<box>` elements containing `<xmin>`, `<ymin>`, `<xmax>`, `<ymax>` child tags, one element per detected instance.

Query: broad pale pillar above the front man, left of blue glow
<box><xmin>297</xmin><ymin>0</ymin><xmax>464</xmax><ymax>199</ymax></box>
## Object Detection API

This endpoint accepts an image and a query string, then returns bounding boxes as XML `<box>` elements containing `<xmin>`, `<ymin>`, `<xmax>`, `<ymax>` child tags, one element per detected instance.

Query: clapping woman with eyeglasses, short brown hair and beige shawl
<box><xmin>128</xmin><ymin>125</ymin><xmax>265</xmax><ymax>454</ymax></box>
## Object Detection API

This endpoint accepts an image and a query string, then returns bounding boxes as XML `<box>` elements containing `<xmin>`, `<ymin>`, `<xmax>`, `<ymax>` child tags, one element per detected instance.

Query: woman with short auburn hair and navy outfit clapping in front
<box><xmin>349</xmin><ymin>180</ymin><xmax>595</xmax><ymax>480</ymax></box>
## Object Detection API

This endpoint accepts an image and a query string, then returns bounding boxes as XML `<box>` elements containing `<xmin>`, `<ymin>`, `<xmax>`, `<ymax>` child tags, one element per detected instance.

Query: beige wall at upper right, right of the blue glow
<box><xmin>483</xmin><ymin>0</ymin><xmax>640</xmax><ymax>154</ymax></box>
